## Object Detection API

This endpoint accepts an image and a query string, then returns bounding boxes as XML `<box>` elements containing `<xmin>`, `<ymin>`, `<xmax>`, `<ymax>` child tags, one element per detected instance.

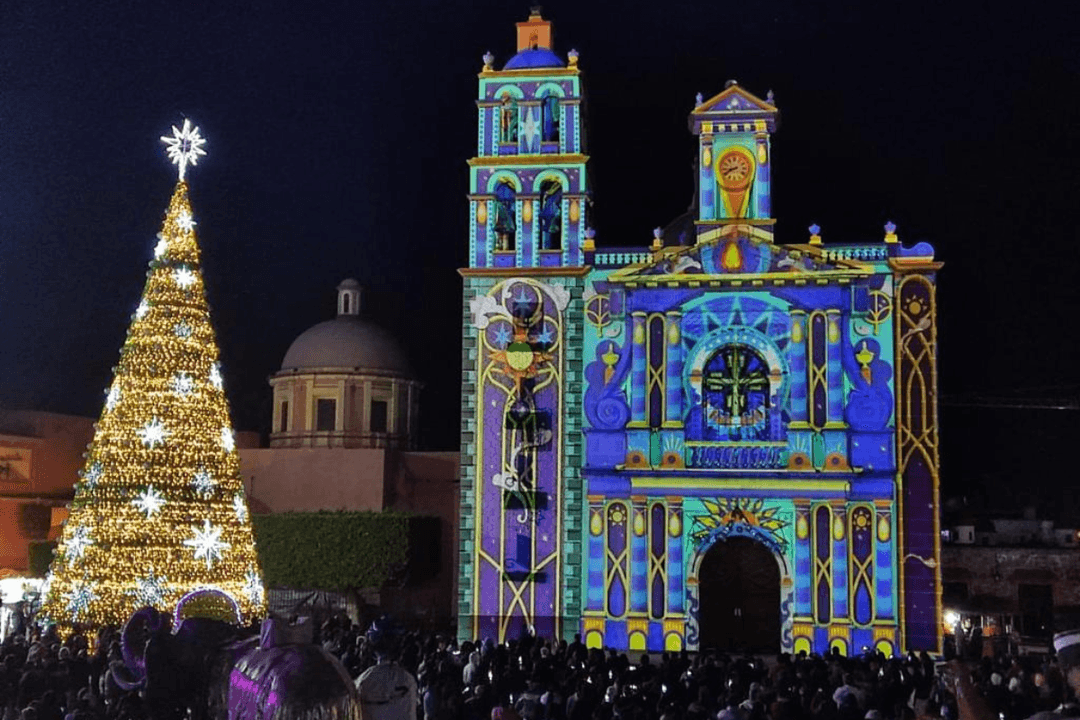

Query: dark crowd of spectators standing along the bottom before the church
<box><xmin>0</xmin><ymin>616</ymin><xmax>1080</xmax><ymax>720</ymax></box>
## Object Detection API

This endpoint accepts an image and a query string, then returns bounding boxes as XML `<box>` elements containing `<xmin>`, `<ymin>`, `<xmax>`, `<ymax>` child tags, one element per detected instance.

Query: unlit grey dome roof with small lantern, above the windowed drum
<box><xmin>281</xmin><ymin>279</ymin><xmax>413</xmax><ymax>376</ymax></box>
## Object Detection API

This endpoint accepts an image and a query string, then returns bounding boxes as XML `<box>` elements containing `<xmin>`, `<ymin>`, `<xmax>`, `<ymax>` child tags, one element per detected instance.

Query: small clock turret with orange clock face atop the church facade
<box><xmin>690</xmin><ymin>80</ymin><xmax>780</xmax><ymax>244</ymax></box>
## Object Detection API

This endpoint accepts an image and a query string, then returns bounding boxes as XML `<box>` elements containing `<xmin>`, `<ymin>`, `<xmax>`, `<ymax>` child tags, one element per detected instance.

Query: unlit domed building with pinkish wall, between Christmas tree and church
<box><xmin>240</xmin><ymin>280</ymin><xmax>459</xmax><ymax>620</ymax></box>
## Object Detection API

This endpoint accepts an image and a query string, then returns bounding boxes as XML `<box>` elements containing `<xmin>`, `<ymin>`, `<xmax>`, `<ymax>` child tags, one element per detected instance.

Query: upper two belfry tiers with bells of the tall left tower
<box><xmin>469</xmin><ymin>9</ymin><xmax>589</xmax><ymax>268</ymax></box>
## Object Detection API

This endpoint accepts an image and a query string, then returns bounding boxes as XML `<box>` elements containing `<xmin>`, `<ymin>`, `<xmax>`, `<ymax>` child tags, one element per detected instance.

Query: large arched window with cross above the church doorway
<box><xmin>701</xmin><ymin>343</ymin><xmax>770</xmax><ymax>440</ymax></box>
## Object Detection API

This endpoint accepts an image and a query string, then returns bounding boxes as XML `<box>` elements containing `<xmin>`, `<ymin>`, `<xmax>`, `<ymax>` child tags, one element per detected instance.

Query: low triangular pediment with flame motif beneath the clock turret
<box><xmin>609</xmin><ymin>232</ymin><xmax>872</xmax><ymax>283</ymax></box>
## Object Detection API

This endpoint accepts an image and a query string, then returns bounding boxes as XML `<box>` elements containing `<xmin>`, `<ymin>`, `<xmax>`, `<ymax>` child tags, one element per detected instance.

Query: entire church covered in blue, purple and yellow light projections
<box><xmin>458</xmin><ymin>12</ymin><xmax>941</xmax><ymax>654</ymax></box>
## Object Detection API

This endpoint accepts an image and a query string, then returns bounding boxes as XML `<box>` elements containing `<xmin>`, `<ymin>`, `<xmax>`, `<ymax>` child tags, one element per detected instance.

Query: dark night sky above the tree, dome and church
<box><xmin>0</xmin><ymin>0</ymin><xmax>1080</xmax><ymax>519</ymax></box>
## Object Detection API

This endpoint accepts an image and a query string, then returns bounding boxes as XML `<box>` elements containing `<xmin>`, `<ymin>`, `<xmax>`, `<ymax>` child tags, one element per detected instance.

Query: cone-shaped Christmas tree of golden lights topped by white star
<box><xmin>42</xmin><ymin>121</ymin><xmax>266</xmax><ymax>633</ymax></box>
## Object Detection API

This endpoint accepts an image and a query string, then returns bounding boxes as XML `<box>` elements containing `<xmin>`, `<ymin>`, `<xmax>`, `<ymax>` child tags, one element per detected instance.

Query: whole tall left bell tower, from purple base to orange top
<box><xmin>458</xmin><ymin>10</ymin><xmax>591</xmax><ymax>640</ymax></box>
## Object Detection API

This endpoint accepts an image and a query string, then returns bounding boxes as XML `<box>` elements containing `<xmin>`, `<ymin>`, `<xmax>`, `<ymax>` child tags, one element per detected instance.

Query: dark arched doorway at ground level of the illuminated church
<box><xmin>698</xmin><ymin>538</ymin><xmax>780</xmax><ymax>653</ymax></box>
